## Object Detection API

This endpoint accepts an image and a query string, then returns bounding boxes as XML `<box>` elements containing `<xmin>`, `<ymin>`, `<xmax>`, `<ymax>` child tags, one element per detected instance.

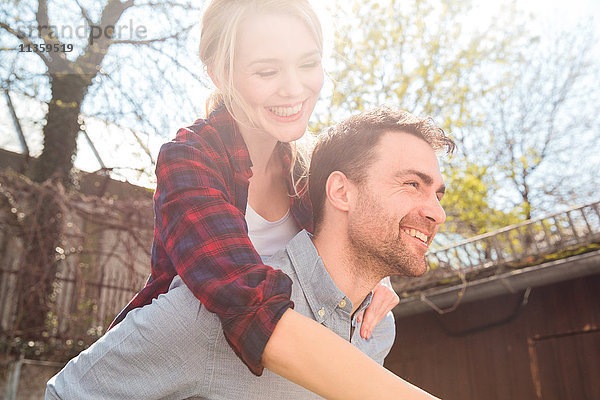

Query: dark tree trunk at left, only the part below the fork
<box><xmin>16</xmin><ymin>74</ymin><xmax>91</xmax><ymax>338</ymax></box>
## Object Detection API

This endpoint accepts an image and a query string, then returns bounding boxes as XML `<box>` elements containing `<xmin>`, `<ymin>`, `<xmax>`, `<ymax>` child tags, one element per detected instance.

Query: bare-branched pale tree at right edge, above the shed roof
<box><xmin>473</xmin><ymin>20</ymin><xmax>600</xmax><ymax>219</ymax></box>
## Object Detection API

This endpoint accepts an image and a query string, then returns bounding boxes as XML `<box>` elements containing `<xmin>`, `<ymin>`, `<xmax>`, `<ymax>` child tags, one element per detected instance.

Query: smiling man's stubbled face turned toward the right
<box><xmin>348</xmin><ymin>132</ymin><xmax>446</xmax><ymax>276</ymax></box>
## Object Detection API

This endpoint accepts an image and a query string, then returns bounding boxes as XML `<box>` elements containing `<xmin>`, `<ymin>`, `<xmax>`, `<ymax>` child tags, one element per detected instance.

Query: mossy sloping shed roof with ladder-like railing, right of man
<box><xmin>392</xmin><ymin>202</ymin><xmax>600</xmax><ymax>316</ymax></box>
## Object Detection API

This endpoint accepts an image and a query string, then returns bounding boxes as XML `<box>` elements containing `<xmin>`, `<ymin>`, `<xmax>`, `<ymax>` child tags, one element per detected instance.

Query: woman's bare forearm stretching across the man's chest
<box><xmin>263</xmin><ymin>310</ymin><xmax>436</xmax><ymax>400</ymax></box>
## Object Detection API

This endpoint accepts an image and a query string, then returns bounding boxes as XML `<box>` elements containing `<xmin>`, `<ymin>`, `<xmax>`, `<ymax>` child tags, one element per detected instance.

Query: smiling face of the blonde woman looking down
<box><xmin>233</xmin><ymin>14</ymin><xmax>323</xmax><ymax>142</ymax></box>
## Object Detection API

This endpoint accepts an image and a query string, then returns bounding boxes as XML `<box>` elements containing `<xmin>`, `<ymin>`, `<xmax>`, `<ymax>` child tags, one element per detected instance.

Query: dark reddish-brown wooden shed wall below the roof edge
<box><xmin>386</xmin><ymin>275</ymin><xmax>600</xmax><ymax>400</ymax></box>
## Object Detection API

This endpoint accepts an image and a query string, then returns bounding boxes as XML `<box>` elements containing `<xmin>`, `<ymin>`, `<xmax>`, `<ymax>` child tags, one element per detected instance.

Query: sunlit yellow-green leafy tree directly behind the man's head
<box><xmin>319</xmin><ymin>0</ymin><xmax>522</xmax><ymax>236</ymax></box>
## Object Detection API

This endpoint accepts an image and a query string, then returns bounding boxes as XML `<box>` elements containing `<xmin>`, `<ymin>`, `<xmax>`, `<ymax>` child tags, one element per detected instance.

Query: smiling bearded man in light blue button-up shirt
<box><xmin>46</xmin><ymin>107</ymin><xmax>454</xmax><ymax>399</ymax></box>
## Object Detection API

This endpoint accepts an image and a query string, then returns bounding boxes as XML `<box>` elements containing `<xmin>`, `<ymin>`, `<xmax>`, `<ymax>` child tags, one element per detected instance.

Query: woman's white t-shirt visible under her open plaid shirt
<box><xmin>246</xmin><ymin>204</ymin><xmax>300</xmax><ymax>261</ymax></box>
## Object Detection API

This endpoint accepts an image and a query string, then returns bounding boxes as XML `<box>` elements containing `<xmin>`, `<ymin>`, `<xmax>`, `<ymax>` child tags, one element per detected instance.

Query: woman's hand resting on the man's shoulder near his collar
<box><xmin>357</xmin><ymin>277</ymin><xmax>400</xmax><ymax>339</ymax></box>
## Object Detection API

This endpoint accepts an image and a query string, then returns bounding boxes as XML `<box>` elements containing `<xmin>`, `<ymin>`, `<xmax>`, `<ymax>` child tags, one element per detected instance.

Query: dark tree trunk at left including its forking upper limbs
<box><xmin>11</xmin><ymin>0</ymin><xmax>133</xmax><ymax>338</ymax></box>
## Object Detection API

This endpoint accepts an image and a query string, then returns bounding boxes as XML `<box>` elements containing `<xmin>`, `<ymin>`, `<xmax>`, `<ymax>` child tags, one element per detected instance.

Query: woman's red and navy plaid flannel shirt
<box><xmin>111</xmin><ymin>107</ymin><xmax>312</xmax><ymax>375</ymax></box>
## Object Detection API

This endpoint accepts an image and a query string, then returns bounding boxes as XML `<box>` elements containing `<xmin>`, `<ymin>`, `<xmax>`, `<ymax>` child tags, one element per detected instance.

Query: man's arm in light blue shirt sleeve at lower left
<box><xmin>45</xmin><ymin>278</ymin><xmax>209</xmax><ymax>400</ymax></box>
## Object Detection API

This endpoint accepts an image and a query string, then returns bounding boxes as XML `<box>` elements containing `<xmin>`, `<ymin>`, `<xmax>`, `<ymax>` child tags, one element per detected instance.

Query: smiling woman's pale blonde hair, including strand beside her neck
<box><xmin>200</xmin><ymin>0</ymin><xmax>323</xmax><ymax>196</ymax></box>
